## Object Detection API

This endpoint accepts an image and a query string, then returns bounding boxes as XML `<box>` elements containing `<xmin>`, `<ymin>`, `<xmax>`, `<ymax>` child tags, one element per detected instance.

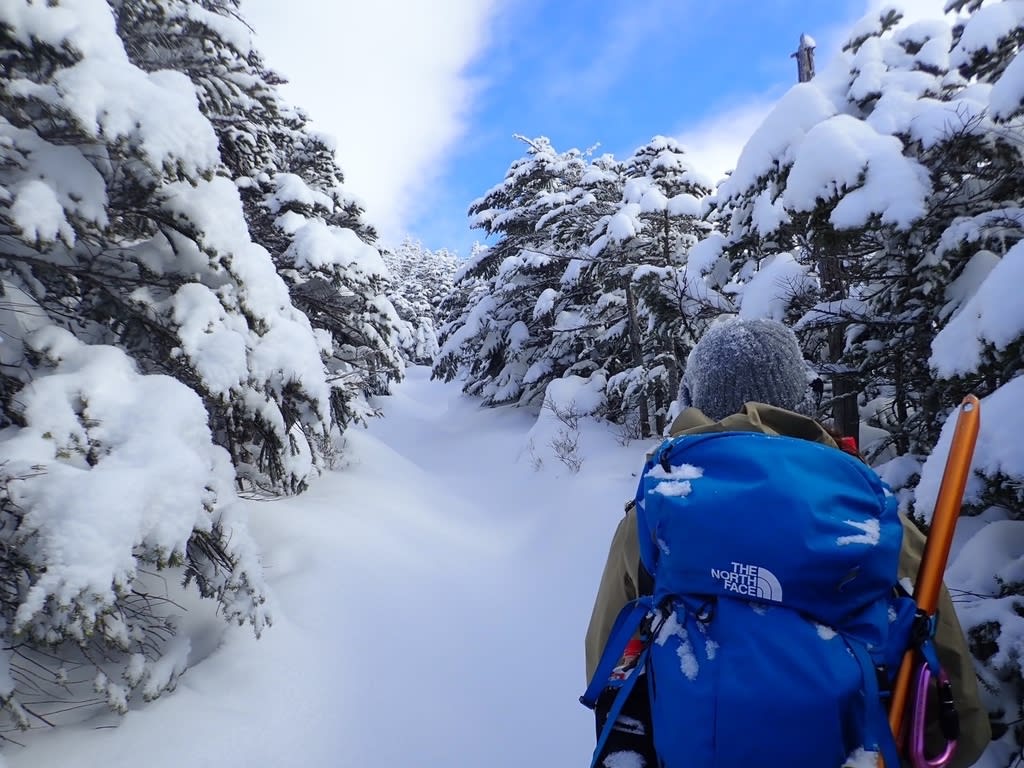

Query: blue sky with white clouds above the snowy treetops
<box><xmin>243</xmin><ymin>0</ymin><xmax>941</xmax><ymax>255</ymax></box>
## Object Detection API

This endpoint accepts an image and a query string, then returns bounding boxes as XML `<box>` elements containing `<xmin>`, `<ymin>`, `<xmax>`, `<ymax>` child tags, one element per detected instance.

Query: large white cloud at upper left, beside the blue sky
<box><xmin>243</xmin><ymin>0</ymin><xmax>498</xmax><ymax>244</ymax></box>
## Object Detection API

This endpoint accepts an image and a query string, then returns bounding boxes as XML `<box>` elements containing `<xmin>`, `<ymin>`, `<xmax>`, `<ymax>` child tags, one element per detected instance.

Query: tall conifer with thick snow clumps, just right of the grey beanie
<box><xmin>719</xmin><ymin>11</ymin><xmax>962</xmax><ymax>451</ymax></box>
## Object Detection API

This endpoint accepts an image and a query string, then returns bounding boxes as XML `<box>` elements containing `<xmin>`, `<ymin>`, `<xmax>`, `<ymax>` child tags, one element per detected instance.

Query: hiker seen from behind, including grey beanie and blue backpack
<box><xmin>584</xmin><ymin>319</ymin><xmax>990</xmax><ymax>768</ymax></box>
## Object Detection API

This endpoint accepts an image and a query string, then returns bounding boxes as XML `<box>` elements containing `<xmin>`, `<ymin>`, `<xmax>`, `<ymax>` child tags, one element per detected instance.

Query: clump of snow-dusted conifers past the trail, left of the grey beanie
<box><xmin>435</xmin><ymin>137</ymin><xmax>731</xmax><ymax>434</ymax></box>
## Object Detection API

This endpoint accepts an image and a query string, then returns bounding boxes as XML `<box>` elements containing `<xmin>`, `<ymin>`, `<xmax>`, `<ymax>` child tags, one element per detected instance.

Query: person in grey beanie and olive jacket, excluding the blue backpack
<box><xmin>586</xmin><ymin>319</ymin><xmax>990</xmax><ymax>768</ymax></box>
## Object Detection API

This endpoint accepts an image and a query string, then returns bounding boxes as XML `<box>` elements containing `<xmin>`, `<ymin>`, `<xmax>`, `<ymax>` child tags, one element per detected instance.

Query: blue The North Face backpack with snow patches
<box><xmin>581</xmin><ymin>432</ymin><xmax>914</xmax><ymax>768</ymax></box>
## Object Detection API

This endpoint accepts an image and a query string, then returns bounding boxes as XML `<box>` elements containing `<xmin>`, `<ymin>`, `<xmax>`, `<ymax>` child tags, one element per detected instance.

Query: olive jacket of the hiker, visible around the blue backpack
<box><xmin>586</xmin><ymin>402</ymin><xmax>991</xmax><ymax>768</ymax></box>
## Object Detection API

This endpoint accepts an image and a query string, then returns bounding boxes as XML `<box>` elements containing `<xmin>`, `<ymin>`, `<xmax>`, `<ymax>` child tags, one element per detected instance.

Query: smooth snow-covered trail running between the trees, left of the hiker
<box><xmin>5</xmin><ymin>369</ymin><xmax>643</xmax><ymax>768</ymax></box>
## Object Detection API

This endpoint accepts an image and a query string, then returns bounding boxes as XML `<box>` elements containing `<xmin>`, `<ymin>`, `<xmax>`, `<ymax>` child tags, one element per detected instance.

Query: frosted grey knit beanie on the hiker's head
<box><xmin>679</xmin><ymin>318</ymin><xmax>808</xmax><ymax>421</ymax></box>
